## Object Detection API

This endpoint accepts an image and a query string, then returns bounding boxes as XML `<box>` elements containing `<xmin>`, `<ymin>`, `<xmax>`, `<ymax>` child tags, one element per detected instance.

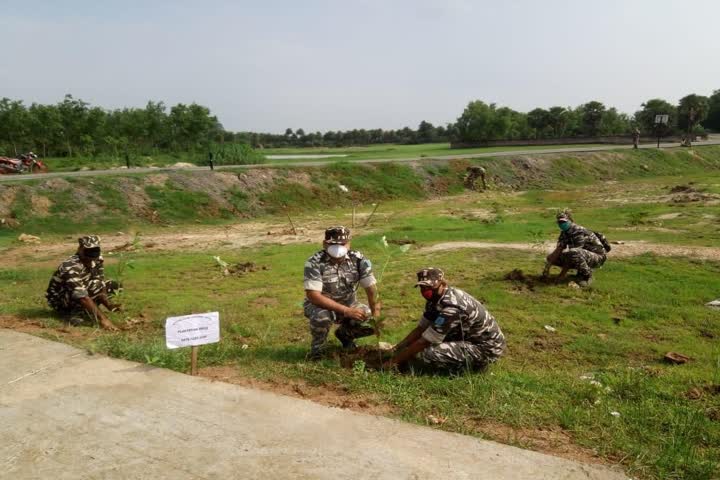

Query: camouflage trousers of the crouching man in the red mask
<box><xmin>410</xmin><ymin>341</ymin><xmax>498</xmax><ymax>373</ymax></box>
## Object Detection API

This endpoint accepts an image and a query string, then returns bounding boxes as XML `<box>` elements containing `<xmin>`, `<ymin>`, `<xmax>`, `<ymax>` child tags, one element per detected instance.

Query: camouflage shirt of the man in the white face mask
<box><xmin>304</xmin><ymin>250</ymin><xmax>376</xmax><ymax>305</ymax></box>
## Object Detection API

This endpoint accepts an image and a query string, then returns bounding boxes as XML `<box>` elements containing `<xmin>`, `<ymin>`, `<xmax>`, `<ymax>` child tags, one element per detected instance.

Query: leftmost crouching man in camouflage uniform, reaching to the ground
<box><xmin>45</xmin><ymin>235</ymin><xmax>120</xmax><ymax>330</ymax></box>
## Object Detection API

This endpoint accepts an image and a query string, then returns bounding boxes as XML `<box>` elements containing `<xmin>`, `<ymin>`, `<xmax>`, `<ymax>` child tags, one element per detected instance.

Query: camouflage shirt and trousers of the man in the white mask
<box><xmin>303</xmin><ymin>250</ymin><xmax>376</xmax><ymax>354</ymax></box>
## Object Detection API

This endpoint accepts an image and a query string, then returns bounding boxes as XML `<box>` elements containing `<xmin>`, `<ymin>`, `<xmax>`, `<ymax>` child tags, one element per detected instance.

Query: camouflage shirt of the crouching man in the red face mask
<box><xmin>419</xmin><ymin>287</ymin><xmax>505</xmax><ymax>357</ymax></box>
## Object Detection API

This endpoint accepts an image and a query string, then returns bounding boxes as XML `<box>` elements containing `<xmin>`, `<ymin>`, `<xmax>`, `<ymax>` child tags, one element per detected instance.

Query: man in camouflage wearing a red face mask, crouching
<box><xmin>384</xmin><ymin>268</ymin><xmax>505</xmax><ymax>373</ymax></box>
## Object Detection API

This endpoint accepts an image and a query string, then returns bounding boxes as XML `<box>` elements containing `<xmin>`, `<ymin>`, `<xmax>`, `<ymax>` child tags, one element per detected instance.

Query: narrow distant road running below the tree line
<box><xmin>0</xmin><ymin>140</ymin><xmax>720</xmax><ymax>183</ymax></box>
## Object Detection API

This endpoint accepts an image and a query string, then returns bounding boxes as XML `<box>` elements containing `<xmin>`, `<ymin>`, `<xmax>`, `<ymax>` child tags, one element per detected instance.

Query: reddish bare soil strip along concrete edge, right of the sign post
<box><xmin>198</xmin><ymin>366</ymin><xmax>394</xmax><ymax>416</ymax></box>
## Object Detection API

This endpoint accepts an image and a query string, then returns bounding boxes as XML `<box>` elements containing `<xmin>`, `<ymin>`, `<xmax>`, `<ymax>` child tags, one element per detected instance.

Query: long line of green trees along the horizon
<box><xmin>0</xmin><ymin>90</ymin><xmax>720</xmax><ymax>156</ymax></box>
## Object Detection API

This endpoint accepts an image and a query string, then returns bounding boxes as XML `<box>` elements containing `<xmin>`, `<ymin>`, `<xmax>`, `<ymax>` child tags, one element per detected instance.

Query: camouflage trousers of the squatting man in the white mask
<box><xmin>304</xmin><ymin>301</ymin><xmax>371</xmax><ymax>353</ymax></box>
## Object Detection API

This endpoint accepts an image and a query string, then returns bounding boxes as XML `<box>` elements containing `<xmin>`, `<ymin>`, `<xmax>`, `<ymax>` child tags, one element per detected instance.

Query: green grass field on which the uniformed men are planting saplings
<box><xmin>0</xmin><ymin>161</ymin><xmax>720</xmax><ymax>479</ymax></box>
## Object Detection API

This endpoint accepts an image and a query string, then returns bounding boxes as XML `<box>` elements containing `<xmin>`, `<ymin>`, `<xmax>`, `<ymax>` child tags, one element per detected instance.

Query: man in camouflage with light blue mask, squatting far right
<box><xmin>543</xmin><ymin>210</ymin><xmax>607</xmax><ymax>287</ymax></box>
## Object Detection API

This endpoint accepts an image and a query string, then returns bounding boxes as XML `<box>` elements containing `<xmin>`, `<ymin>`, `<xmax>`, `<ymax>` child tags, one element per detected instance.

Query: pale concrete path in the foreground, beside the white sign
<box><xmin>0</xmin><ymin>329</ymin><xmax>625</xmax><ymax>480</ymax></box>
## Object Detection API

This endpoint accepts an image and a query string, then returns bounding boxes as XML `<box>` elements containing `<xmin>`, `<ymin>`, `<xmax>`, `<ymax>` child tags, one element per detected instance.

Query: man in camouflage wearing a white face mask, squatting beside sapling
<box><xmin>304</xmin><ymin>226</ymin><xmax>380</xmax><ymax>359</ymax></box>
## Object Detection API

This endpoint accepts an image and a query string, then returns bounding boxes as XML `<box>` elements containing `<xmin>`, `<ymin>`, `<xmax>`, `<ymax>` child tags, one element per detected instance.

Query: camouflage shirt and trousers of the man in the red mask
<box><xmin>417</xmin><ymin>287</ymin><xmax>505</xmax><ymax>371</ymax></box>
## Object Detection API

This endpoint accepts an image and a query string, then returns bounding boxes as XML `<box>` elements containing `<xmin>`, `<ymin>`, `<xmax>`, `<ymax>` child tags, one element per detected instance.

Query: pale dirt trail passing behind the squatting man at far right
<box><xmin>418</xmin><ymin>241</ymin><xmax>720</xmax><ymax>261</ymax></box>
